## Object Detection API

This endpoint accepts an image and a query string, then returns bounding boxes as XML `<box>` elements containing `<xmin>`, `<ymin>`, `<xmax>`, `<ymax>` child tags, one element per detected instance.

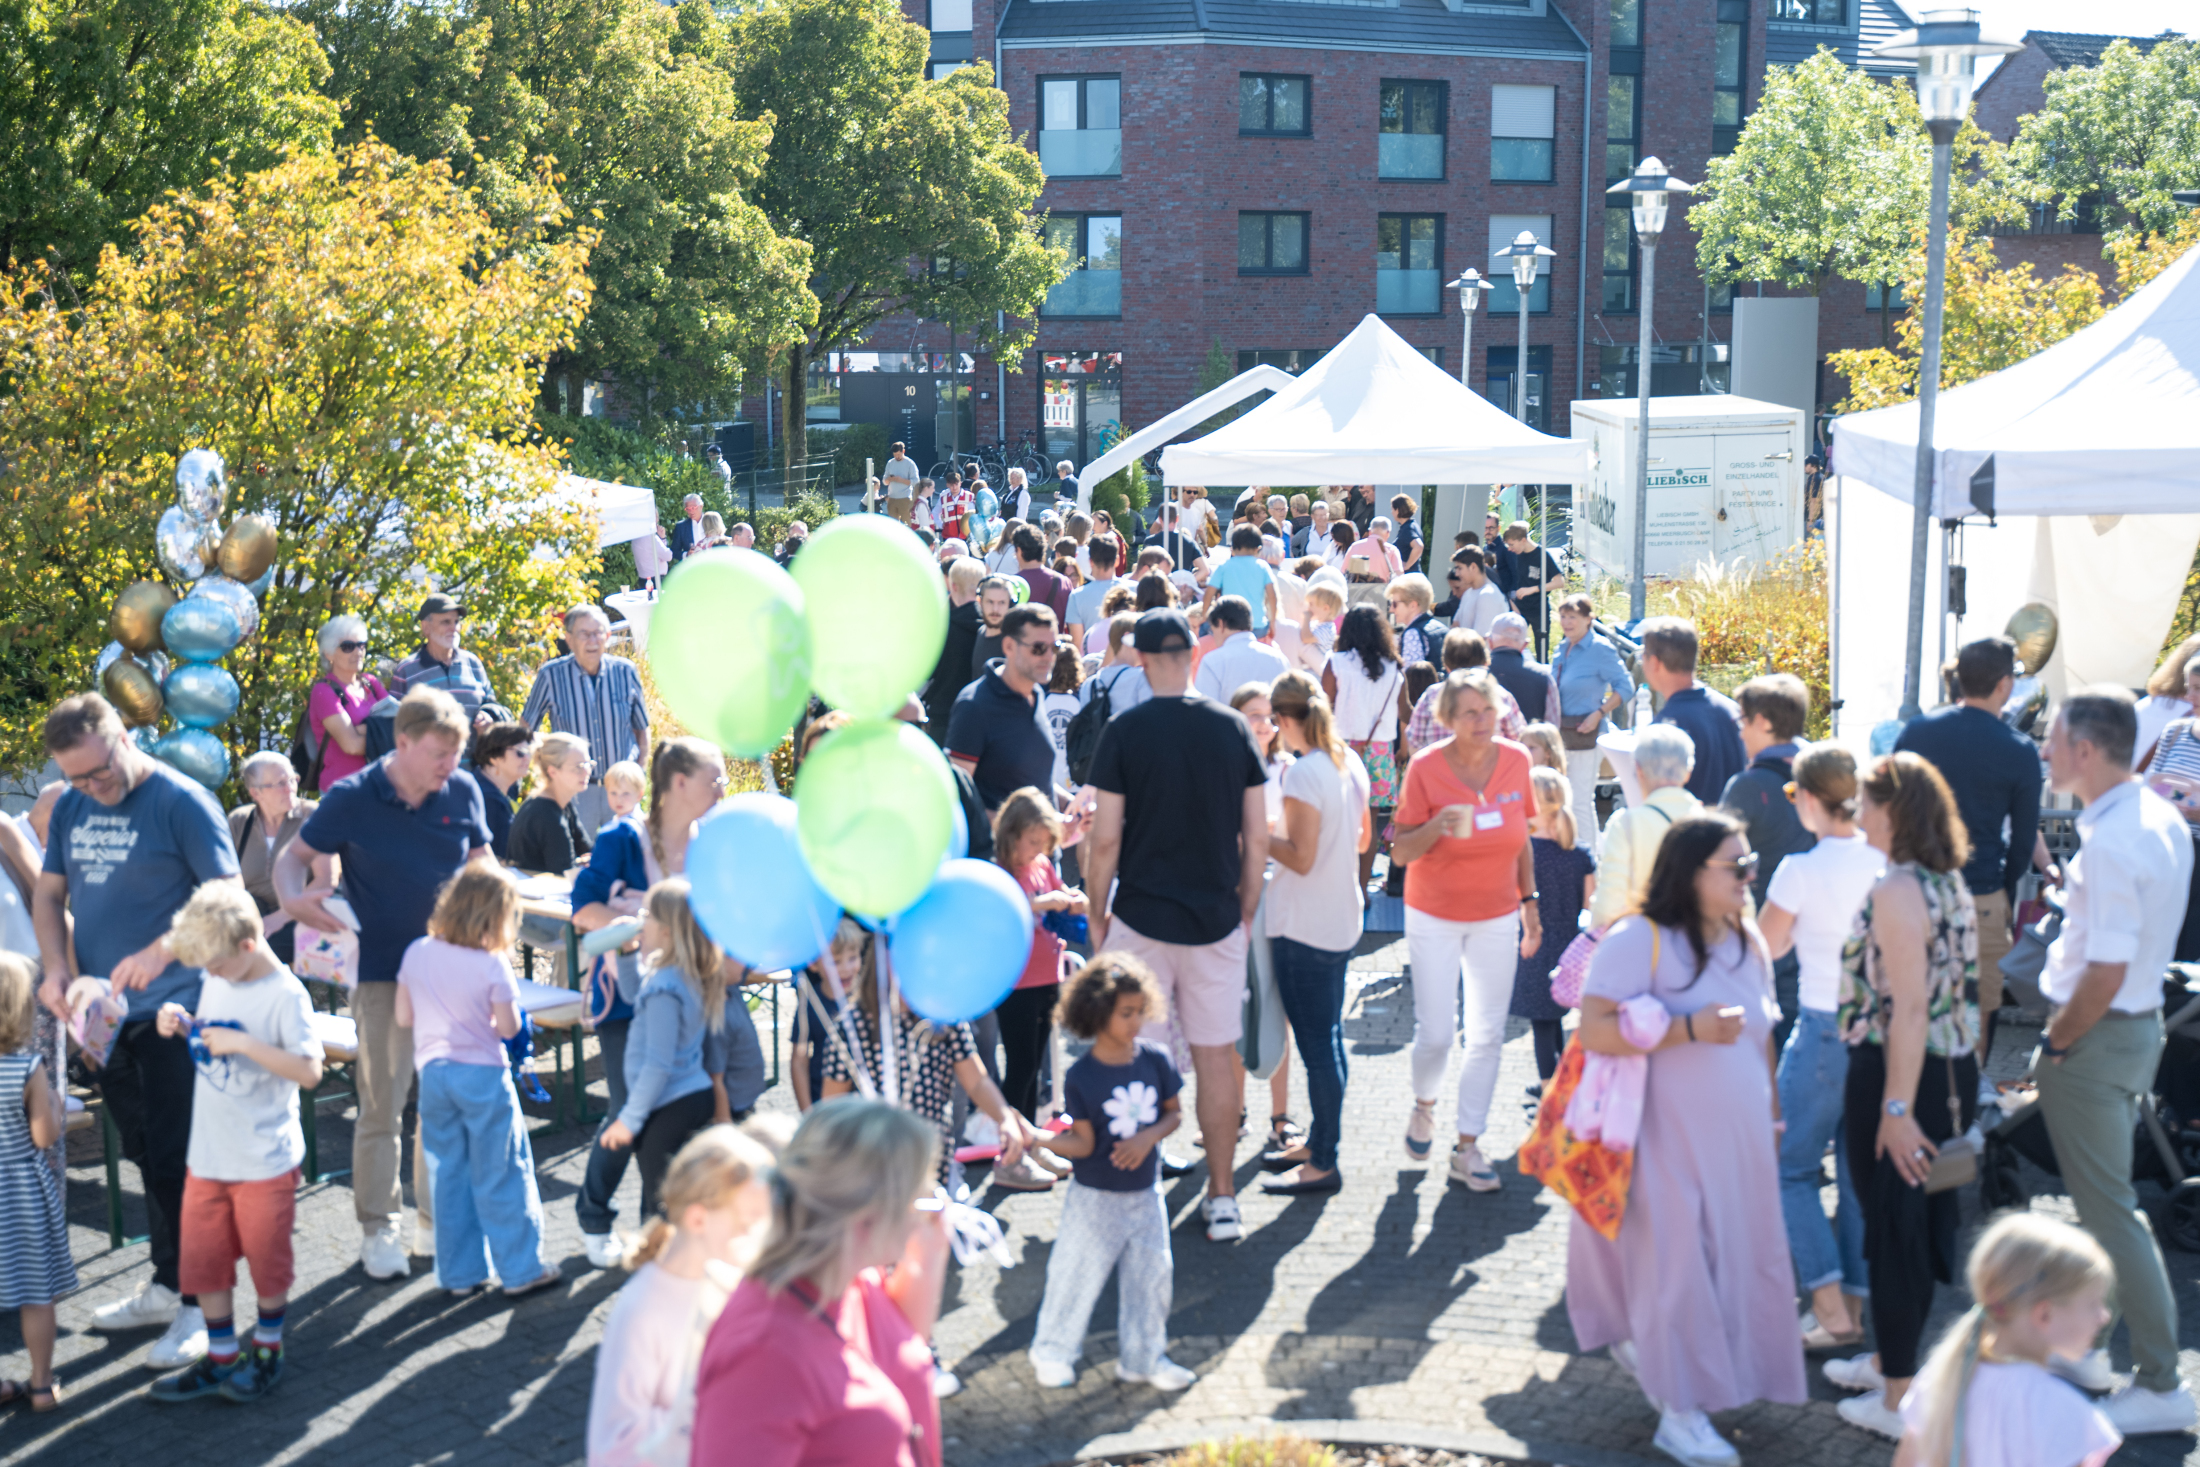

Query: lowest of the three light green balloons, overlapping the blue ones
<box><xmin>794</xmin><ymin>712</ymin><xmax>957</xmax><ymax>917</ymax></box>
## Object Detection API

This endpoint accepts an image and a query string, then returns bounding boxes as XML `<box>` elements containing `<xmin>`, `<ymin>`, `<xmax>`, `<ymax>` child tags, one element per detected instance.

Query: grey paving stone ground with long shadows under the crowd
<box><xmin>0</xmin><ymin>935</ymin><xmax>2200</xmax><ymax>1467</ymax></box>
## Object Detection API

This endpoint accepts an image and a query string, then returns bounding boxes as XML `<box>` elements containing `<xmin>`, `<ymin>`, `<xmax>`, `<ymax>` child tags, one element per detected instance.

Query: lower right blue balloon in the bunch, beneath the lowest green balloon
<box><xmin>888</xmin><ymin>858</ymin><xmax>1032</xmax><ymax>1025</ymax></box>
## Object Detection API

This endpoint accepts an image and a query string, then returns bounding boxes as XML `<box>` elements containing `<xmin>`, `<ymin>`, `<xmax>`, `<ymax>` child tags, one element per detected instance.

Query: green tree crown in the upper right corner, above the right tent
<box><xmin>2011</xmin><ymin>37</ymin><xmax>2200</xmax><ymax>233</ymax></box>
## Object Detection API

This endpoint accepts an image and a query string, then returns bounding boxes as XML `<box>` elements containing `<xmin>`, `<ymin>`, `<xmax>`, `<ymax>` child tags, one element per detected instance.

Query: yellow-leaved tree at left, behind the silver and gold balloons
<box><xmin>0</xmin><ymin>143</ymin><xmax>594</xmax><ymax>768</ymax></box>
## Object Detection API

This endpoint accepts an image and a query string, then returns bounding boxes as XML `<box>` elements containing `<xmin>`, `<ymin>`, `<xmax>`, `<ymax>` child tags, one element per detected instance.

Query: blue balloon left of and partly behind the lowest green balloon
<box><xmin>686</xmin><ymin>794</ymin><xmax>840</xmax><ymax>972</ymax></box>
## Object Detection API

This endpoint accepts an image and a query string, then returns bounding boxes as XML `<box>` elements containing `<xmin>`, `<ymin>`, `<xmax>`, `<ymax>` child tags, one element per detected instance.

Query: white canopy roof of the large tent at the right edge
<box><xmin>1833</xmin><ymin>251</ymin><xmax>2200</xmax><ymax>519</ymax></box>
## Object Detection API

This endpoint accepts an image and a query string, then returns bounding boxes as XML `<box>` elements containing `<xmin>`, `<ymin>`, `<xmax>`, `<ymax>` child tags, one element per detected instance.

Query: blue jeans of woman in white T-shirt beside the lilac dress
<box><xmin>1780</xmin><ymin>1010</ymin><xmax>1872</xmax><ymax>1295</ymax></box>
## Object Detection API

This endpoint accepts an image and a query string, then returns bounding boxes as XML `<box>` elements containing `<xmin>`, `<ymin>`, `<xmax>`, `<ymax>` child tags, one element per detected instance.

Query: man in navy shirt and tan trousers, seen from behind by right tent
<box><xmin>1894</xmin><ymin>636</ymin><xmax>2044</xmax><ymax>1054</ymax></box>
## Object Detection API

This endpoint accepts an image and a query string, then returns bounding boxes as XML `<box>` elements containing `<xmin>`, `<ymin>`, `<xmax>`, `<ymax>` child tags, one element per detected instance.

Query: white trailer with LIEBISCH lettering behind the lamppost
<box><xmin>1573</xmin><ymin>394</ymin><xmax>1811</xmax><ymax>578</ymax></box>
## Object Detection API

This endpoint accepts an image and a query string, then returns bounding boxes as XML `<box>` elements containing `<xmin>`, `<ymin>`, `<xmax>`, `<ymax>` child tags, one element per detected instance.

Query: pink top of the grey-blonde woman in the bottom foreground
<box><xmin>691</xmin><ymin>1269</ymin><xmax>939</xmax><ymax>1467</ymax></box>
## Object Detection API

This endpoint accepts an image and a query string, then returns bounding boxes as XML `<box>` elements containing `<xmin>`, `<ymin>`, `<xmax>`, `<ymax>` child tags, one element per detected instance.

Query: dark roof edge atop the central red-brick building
<box><xmin>999</xmin><ymin>0</ymin><xmax>1584</xmax><ymax>57</ymax></box>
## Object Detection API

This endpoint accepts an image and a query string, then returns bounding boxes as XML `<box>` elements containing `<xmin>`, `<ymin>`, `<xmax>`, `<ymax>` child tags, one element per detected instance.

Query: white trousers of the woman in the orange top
<box><xmin>1406</xmin><ymin>906</ymin><xmax>1520</xmax><ymax>1137</ymax></box>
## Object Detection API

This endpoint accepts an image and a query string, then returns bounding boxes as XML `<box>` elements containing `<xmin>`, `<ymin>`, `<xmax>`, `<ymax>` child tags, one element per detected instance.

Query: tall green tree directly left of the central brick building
<box><xmin>728</xmin><ymin>0</ymin><xmax>1065</xmax><ymax>468</ymax></box>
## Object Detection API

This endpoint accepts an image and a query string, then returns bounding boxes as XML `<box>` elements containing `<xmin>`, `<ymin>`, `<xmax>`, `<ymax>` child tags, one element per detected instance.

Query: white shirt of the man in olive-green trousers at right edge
<box><xmin>2032</xmin><ymin>781</ymin><xmax>2193</xmax><ymax>1014</ymax></box>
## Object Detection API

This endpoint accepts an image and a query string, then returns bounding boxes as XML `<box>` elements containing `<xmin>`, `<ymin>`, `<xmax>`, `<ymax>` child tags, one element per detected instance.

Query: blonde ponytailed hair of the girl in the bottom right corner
<box><xmin>1914</xmin><ymin>1212</ymin><xmax>2116</xmax><ymax>1467</ymax></box>
